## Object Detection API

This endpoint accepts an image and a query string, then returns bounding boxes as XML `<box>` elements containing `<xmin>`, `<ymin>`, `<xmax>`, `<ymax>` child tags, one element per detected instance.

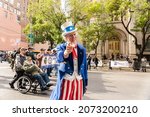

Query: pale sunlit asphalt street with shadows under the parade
<box><xmin>0</xmin><ymin>62</ymin><xmax>150</xmax><ymax>100</ymax></box>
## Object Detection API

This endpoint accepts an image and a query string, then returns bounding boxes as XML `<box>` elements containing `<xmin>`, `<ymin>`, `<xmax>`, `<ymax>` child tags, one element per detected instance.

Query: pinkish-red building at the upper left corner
<box><xmin>0</xmin><ymin>0</ymin><xmax>27</xmax><ymax>51</ymax></box>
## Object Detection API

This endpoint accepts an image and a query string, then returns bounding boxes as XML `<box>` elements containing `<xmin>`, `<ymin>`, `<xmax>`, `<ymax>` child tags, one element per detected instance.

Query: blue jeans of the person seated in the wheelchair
<box><xmin>33</xmin><ymin>73</ymin><xmax>50</xmax><ymax>89</ymax></box>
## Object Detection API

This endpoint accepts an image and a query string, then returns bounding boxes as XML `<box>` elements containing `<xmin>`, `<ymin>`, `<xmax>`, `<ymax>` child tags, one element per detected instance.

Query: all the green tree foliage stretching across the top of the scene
<box><xmin>24</xmin><ymin>0</ymin><xmax>150</xmax><ymax>58</ymax></box>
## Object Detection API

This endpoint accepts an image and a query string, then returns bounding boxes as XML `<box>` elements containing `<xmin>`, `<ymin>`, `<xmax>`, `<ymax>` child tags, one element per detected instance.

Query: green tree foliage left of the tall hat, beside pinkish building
<box><xmin>24</xmin><ymin>0</ymin><xmax>66</xmax><ymax>46</ymax></box>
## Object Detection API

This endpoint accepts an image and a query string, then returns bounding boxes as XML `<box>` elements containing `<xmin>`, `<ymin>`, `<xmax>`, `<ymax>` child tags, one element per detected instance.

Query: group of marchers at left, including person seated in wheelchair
<box><xmin>9</xmin><ymin>47</ymin><xmax>57</xmax><ymax>91</ymax></box>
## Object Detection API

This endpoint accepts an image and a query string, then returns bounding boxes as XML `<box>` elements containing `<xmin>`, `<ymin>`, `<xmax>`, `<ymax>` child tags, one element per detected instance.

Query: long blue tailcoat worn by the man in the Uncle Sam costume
<box><xmin>50</xmin><ymin>43</ymin><xmax>88</xmax><ymax>100</ymax></box>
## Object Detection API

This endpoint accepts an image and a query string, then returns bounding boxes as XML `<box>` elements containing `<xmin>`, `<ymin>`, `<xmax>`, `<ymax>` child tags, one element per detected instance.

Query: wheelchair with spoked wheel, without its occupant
<box><xmin>17</xmin><ymin>72</ymin><xmax>39</xmax><ymax>94</ymax></box>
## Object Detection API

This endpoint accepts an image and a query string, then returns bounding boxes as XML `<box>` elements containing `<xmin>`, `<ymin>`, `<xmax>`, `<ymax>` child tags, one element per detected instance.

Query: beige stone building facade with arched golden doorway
<box><xmin>97</xmin><ymin>19</ymin><xmax>150</xmax><ymax>61</ymax></box>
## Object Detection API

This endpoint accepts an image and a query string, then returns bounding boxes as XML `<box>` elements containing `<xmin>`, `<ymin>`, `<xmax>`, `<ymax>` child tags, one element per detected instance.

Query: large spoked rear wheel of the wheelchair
<box><xmin>17</xmin><ymin>76</ymin><xmax>32</xmax><ymax>94</ymax></box>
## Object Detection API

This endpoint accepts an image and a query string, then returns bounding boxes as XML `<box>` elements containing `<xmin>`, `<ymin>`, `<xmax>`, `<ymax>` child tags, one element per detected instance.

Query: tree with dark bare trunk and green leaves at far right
<box><xmin>106</xmin><ymin>0</ymin><xmax>150</xmax><ymax>58</ymax></box>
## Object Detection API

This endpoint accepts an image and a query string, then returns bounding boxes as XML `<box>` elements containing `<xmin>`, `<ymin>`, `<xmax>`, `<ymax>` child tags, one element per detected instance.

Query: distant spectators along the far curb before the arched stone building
<box><xmin>87</xmin><ymin>54</ymin><xmax>150</xmax><ymax>72</ymax></box>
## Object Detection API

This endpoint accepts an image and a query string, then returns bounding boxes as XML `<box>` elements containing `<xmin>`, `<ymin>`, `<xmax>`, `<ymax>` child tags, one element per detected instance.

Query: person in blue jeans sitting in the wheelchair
<box><xmin>23</xmin><ymin>56</ymin><xmax>51</xmax><ymax>91</ymax></box>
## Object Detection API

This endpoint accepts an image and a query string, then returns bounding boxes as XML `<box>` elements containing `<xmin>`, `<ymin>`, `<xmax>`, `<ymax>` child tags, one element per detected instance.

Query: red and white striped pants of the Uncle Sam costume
<box><xmin>60</xmin><ymin>79</ymin><xmax>83</xmax><ymax>100</ymax></box>
